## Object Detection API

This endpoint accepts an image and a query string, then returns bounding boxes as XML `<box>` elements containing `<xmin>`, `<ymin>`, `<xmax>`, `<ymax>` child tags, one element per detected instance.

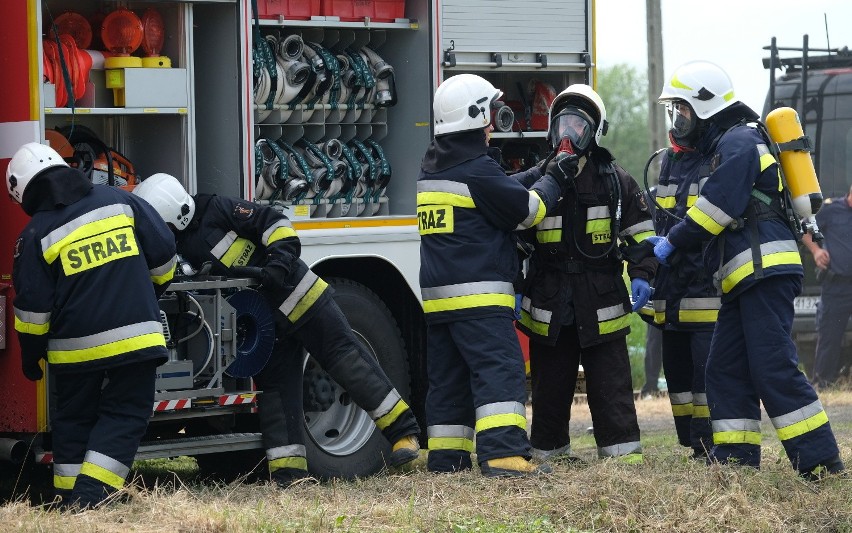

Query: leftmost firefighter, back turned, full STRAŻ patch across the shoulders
<box><xmin>6</xmin><ymin>143</ymin><xmax>176</xmax><ymax>509</ymax></box>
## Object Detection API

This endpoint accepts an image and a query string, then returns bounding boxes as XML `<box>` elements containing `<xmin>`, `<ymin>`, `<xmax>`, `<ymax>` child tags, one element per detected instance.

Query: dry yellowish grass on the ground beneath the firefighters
<box><xmin>0</xmin><ymin>392</ymin><xmax>852</xmax><ymax>533</ymax></box>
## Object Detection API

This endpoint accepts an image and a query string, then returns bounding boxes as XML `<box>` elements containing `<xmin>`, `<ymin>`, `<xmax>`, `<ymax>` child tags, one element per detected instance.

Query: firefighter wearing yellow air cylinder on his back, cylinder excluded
<box><xmin>654</xmin><ymin>61</ymin><xmax>844</xmax><ymax>479</ymax></box>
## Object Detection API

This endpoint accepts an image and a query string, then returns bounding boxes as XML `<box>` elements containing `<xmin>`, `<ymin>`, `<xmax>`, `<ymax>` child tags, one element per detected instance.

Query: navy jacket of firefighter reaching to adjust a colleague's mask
<box><xmin>417</xmin><ymin>130</ymin><xmax>560</xmax><ymax>323</ymax></box>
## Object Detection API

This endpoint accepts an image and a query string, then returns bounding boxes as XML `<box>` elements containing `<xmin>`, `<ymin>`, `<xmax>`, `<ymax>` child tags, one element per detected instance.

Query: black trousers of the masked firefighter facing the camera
<box><xmin>530</xmin><ymin>325</ymin><xmax>642</xmax><ymax>457</ymax></box>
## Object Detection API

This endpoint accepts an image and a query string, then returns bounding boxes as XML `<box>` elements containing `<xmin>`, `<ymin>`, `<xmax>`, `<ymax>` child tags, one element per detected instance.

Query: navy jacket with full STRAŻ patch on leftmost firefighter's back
<box><xmin>12</xmin><ymin>167</ymin><xmax>176</xmax><ymax>374</ymax></box>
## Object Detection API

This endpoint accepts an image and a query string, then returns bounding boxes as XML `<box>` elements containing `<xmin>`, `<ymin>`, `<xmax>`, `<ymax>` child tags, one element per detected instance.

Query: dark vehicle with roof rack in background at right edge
<box><xmin>763</xmin><ymin>35</ymin><xmax>852</xmax><ymax>376</ymax></box>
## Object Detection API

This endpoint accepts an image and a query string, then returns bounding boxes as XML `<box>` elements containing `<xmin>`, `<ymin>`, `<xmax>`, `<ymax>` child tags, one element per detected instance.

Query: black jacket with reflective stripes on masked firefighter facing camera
<box><xmin>518</xmin><ymin>149</ymin><xmax>657</xmax><ymax>346</ymax></box>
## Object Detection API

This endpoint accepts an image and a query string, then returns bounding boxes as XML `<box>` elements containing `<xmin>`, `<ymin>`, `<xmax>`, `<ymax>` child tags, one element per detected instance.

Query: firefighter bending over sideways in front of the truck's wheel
<box><xmin>133</xmin><ymin>174</ymin><xmax>420</xmax><ymax>486</ymax></box>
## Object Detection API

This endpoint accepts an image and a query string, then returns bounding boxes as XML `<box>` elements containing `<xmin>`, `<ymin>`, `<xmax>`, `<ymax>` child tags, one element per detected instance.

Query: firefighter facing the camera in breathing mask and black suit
<box><xmin>518</xmin><ymin>84</ymin><xmax>657</xmax><ymax>463</ymax></box>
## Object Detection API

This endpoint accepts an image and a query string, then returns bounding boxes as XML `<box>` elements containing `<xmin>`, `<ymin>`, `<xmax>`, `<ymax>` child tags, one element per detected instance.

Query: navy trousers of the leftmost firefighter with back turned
<box><xmin>52</xmin><ymin>360</ymin><xmax>157</xmax><ymax>509</ymax></box>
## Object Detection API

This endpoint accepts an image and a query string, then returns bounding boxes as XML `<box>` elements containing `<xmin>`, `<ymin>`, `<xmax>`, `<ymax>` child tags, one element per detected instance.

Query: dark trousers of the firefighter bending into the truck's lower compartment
<box><xmin>258</xmin><ymin>298</ymin><xmax>420</xmax><ymax>477</ymax></box>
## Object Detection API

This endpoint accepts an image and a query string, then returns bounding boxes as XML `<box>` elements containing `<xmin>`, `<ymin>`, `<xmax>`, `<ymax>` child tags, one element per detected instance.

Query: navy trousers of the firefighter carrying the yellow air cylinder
<box><xmin>706</xmin><ymin>275</ymin><xmax>838</xmax><ymax>472</ymax></box>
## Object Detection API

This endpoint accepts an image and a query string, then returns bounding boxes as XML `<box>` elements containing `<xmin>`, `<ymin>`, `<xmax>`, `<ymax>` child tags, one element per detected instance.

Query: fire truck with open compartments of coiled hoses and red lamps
<box><xmin>0</xmin><ymin>0</ymin><xmax>595</xmax><ymax>478</ymax></box>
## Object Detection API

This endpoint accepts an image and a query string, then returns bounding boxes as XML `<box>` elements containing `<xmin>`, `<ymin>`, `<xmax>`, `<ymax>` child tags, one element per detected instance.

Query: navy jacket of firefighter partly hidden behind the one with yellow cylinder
<box><xmin>640</xmin><ymin>148</ymin><xmax>721</xmax><ymax>331</ymax></box>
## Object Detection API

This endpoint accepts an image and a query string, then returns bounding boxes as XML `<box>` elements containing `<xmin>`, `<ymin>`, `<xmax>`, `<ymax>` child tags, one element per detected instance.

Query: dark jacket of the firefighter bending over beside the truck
<box><xmin>177</xmin><ymin>194</ymin><xmax>332</xmax><ymax>329</ymax></box>
